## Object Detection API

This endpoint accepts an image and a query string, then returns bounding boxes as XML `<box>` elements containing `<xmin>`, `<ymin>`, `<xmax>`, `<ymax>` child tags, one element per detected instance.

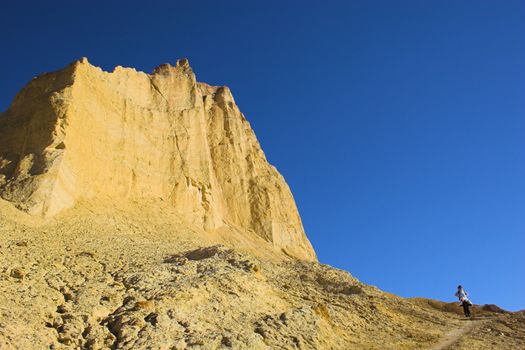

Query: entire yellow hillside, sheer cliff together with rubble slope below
<box><xmin>0</xmin><ymin>60</ymin><xmax>525</xmax><ymax>350</ymax></box>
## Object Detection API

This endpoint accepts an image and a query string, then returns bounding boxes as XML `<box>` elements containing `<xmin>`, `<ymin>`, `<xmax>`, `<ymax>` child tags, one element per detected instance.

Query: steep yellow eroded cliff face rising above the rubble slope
<box><xmin>0</xmin><ymin>59</ymin><xmax>316</xmax><ymax>260</ymax></box>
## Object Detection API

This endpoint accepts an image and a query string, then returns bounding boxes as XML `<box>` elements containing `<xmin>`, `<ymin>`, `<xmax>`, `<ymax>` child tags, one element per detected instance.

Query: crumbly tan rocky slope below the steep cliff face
<box><xmin>0</xmin><ymin>201</ymin><xmax>525</xmax><ymax>349</ymax></box>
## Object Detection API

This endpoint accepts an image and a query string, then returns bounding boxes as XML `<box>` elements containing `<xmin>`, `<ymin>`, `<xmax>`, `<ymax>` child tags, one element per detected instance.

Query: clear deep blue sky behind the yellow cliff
<box><xmin>0</xmin><ymin>0</ymin><xmax>525</xmax><ymax>310</ymax></box>
